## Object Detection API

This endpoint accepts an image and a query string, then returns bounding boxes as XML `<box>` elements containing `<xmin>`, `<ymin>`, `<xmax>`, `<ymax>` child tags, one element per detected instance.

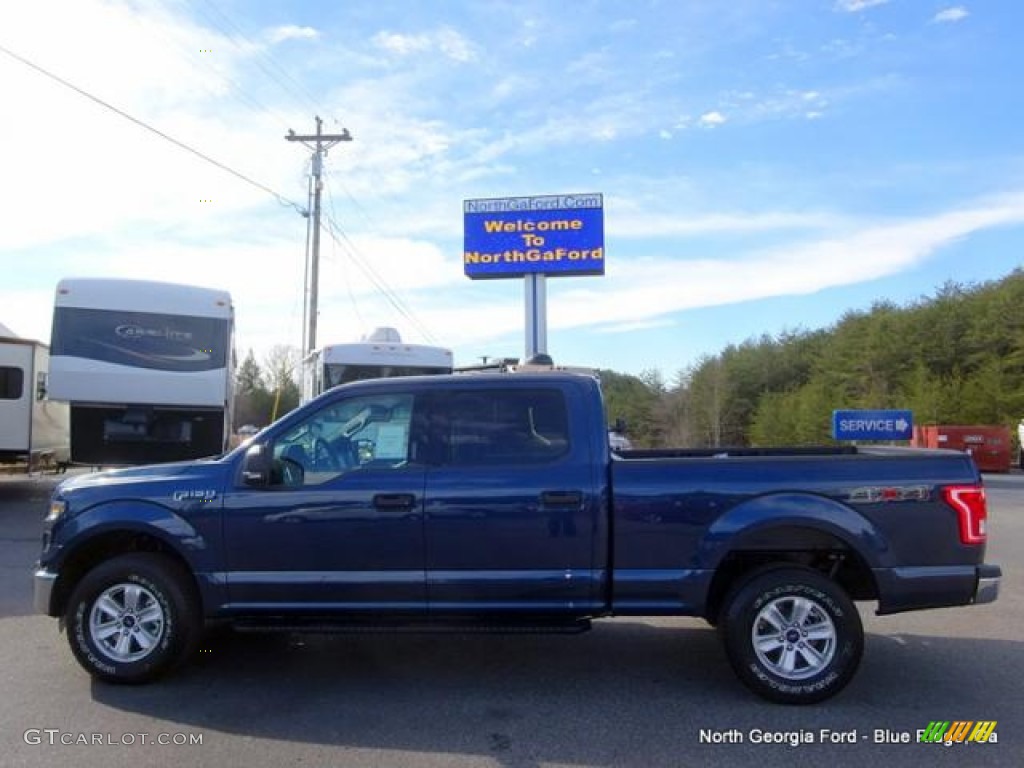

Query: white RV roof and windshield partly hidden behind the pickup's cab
<box><xmin>302</xmin><ymin>328</ymin><xmax>452</xmax><ymax>402</ymax></box>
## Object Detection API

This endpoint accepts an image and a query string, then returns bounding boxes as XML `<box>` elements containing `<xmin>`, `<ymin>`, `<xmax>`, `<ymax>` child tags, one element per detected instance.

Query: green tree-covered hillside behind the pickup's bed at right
<box><xmin>601</xmin><ymin>269</ymin><xmax>1024</xmax><ymax>446</ymax></box>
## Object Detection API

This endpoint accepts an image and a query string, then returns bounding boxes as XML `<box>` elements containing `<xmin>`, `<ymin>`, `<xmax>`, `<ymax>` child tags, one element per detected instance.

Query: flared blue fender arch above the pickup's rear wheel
<box><xmin>697</xmin><ymin>493</ymin><xmax>889</xmax><ymax>570</ymax></box>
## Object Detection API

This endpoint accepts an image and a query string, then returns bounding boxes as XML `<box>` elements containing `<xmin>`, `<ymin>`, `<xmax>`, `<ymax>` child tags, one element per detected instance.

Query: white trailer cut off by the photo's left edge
<box><xmin>0</xmin><ymin>336</ymin><xmax>71</xmax><ymax>472</ymax></box>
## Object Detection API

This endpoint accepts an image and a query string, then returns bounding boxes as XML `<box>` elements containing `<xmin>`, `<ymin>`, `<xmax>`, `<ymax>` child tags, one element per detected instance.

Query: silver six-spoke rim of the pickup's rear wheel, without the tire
<box><xmin>751</xmin><ymin>597</ymin><xmax>837</xmax><ymax>680</ymax></box>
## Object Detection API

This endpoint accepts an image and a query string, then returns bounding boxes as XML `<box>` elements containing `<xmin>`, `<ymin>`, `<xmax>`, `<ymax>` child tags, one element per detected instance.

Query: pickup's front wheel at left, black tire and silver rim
<box><xmin>65</xmin><ymin>553</ymin><xmax>203</xmax><ymax>683</ymax></box>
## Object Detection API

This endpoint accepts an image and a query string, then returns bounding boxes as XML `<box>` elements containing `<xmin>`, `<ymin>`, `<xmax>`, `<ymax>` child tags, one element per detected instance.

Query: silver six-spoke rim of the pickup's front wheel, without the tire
<box><xmin>89</xmin><ymin>583</ymin><xmax>167</xmax><ymax>664</ymax></box>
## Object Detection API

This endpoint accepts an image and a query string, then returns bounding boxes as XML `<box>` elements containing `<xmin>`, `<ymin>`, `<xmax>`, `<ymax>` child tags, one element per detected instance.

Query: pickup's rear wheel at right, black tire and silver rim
<box><xmin>719</xmin><ymin>567</ymin><xmax>864</xmax><ymax>705</ymax></box>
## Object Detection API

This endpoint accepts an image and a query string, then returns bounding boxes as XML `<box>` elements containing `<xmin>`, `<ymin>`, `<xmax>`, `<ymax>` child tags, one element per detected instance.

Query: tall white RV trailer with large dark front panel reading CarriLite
<box><xmin>49</xmin><ymin>279</ymin><xmax>234</xmax><ymax>466</ymax></box>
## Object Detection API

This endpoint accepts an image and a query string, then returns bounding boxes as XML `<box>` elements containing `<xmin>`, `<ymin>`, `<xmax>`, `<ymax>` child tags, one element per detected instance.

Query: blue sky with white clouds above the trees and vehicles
<box><xmin>0</xmin><ymin>0</ymin><xmax>1024</xmax><ymax>378</ymax></box>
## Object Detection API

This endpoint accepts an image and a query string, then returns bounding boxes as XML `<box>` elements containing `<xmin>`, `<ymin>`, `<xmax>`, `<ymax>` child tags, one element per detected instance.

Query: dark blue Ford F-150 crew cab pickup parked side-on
<box><xmin>35</xmin><ymin>372</ymin><xmax>1000</xmax><ymax>703</ymax></box>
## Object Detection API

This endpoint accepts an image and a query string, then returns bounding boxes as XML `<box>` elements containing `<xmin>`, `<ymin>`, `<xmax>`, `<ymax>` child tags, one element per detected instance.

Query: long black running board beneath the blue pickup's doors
<box><xmin>230</xmin><ymin>616</ymin><xmax>591</xmax><ymax>635</ymax></box>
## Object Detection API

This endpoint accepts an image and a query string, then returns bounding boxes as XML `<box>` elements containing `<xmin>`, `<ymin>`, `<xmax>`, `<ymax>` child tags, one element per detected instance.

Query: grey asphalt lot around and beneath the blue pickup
<box><xmin>0</xmin><ymin>474</ymin><xmax>1024</xmax><ymax>768</ymax></box>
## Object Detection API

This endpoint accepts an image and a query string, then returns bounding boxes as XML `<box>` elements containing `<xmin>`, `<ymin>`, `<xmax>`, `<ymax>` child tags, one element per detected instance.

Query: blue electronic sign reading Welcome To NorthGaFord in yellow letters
<box><xmin>463</xmin><ymin>194</ymin><xmax>604</xmax><ymax>280</ymax></box>
